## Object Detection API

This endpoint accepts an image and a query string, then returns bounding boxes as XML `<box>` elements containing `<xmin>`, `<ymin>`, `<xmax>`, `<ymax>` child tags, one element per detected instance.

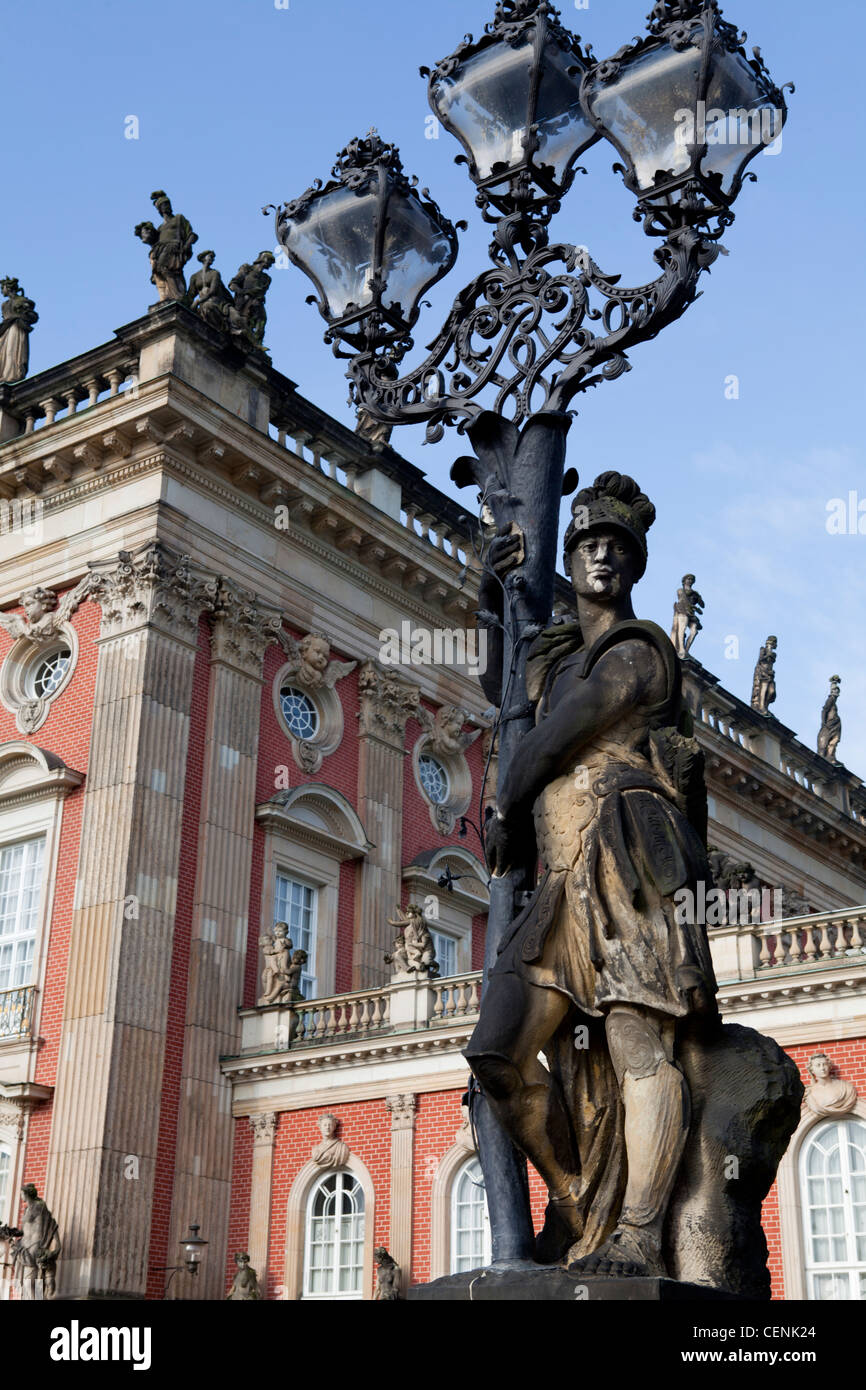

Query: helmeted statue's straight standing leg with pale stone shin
<box><xmin>571</xmin><ymin>1005</ymin><xmax>689</xmax><ymax>1276</ymax></box>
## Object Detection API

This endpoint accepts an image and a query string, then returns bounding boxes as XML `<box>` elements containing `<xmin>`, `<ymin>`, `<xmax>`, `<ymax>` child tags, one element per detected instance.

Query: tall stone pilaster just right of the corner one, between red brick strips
<box><xmin>170</xmin><ymin>582</ymin><xmax>282</xmax><ymax>1298</ymax></box>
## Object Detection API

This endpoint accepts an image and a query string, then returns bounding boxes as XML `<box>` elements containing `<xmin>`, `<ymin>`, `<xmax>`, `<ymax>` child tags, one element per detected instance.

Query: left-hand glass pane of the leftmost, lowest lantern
<box><xmin>285</xmin><ymin>188</ymin><xmax>378</xmax><ymax>318</ymax></box>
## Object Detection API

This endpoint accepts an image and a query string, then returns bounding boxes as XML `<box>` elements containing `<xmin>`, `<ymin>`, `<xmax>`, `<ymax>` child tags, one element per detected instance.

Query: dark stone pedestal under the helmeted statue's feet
<box><xmin>409</xmin><ymin>1265</ymin><xmax>746</xmax><ymax>1304</ymax></box>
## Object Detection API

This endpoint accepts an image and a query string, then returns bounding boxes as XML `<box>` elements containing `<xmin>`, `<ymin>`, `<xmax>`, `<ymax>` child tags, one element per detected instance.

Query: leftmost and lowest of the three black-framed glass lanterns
<box><xmin>277</xmin><ymin>136</ymin><xmax>457</xmax><ymax>339</ymax></box>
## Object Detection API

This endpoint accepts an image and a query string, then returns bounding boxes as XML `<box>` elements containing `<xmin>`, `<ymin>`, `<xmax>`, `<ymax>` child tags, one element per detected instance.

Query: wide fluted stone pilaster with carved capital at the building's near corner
<box><xmin>46</xmin><ymin>542</ymin><xmax>217</xmax><ymax>1297</ymax></box>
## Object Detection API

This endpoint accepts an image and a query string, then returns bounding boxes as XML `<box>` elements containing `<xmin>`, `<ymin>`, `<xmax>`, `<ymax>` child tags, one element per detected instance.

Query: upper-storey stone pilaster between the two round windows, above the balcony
<box><xmin>353</xmin><ymin>662</ymin><xmax>421</xmax><ymax>990</ymax></box>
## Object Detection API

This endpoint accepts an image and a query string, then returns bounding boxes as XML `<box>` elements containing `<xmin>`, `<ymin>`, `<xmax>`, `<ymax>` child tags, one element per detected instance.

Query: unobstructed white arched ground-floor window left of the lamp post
<box><xmin>303</xmin><ymin>1170</ymin><xmax>364</xmax><ymax>1298</ymax></box>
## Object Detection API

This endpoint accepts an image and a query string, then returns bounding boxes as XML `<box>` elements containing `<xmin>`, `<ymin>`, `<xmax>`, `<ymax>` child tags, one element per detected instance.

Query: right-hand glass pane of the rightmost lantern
<box><xmin>702</xmin><ymin>53</ymin><xmax>784</xmax><ymax>193</ymax></box>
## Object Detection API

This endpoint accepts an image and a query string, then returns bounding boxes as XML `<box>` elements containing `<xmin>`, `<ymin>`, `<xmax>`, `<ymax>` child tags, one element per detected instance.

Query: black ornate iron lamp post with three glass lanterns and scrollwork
<box><xmin>265</xmin><ymin>0</ymin><xmax>787</xmax><ymax>1262</ymax></box>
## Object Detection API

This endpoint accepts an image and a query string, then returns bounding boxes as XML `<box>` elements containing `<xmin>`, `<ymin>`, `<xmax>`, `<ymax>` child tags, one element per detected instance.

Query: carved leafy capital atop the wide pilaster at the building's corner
<box><xmin>92</xmin><ymin>541</ymin><xmax>220</xmax><ymax>641</ymax></box>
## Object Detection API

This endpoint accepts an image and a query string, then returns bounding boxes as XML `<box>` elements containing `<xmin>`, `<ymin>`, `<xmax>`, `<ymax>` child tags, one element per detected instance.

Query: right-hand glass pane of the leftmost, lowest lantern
<box><xmin>382</xmin><ymin>193</ymin><xmax>455</xmax><ymax>322</ymax></box>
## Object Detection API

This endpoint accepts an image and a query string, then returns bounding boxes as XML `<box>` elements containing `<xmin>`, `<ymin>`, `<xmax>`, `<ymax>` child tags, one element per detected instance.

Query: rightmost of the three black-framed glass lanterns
<box><xmin>582</xmin><ymin>3</ymin><xmax>787</xmax><ymax>207</ymax></box>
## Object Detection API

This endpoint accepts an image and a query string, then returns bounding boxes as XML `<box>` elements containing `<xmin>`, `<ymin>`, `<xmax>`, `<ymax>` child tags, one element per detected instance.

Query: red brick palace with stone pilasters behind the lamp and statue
<box><xmin>0</xmin><ymin>300</ymin><xmax>866</xmax><ymax>1300</ymax></box>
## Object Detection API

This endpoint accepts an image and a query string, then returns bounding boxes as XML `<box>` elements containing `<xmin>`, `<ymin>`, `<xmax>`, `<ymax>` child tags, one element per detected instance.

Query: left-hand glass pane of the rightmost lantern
<box><xmin>591</xmin><ymin>47</ymin><xmax>701</xmax><ymax>192</ymax></box>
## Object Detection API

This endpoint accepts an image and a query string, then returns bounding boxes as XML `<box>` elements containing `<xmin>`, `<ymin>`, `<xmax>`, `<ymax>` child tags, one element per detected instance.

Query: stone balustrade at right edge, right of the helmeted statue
<box><xmin>710</xmin><ymin>906</ymin><xmax>866</xmax><ymax>983</ymax></box>
